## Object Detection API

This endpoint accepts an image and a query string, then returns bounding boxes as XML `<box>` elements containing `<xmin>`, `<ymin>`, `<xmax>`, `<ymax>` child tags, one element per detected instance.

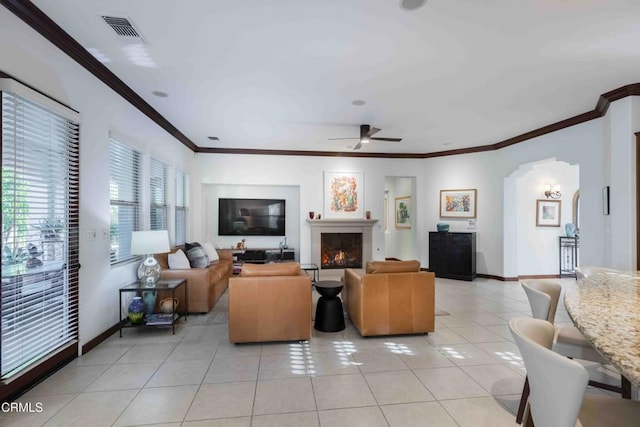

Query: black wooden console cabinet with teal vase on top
<box><xmin>429</xmin><ymin>231</ymin><xmax>476</xmax><ymax>281</ymax></box>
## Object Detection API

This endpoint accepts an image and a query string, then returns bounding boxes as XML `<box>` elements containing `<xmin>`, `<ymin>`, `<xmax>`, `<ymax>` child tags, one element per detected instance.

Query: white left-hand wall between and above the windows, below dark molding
<box><xmin>0</xmin><ymin>7</ymin><xmax>193</xmax><ymax>346</ymax></box>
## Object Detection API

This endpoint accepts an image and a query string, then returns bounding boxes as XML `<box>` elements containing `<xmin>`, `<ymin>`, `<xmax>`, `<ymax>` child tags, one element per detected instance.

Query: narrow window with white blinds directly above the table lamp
<box><xmin>109</xmin><ymin>139</ymin><xmax>141</xmax><ymax>264</ymax></box>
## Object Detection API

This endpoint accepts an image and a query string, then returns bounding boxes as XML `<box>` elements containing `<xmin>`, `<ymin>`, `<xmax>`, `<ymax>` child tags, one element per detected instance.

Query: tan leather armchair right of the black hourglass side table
<box><xmin>342</xmin><ymin>260</ymin><xmax>435</xmax><ymax>336</ymax></box>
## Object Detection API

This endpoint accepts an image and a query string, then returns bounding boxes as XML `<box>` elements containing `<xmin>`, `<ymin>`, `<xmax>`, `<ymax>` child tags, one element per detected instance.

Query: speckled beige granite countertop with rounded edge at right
<box><xmin>564</xmin><ymin>272</ymin><xmax>640</xmax><ymax>385</ymax></box>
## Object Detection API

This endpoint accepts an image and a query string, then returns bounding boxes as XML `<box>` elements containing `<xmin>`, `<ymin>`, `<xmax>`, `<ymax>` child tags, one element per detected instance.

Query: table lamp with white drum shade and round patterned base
<box><xmin>131</xmin><ymin>230</ymin><xmax>170</xmax><ymax>285</ymax></box>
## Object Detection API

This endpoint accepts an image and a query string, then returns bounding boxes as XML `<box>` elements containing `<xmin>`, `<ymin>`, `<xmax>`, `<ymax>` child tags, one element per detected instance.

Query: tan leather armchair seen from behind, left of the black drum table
<box><xmin>229</xmin><ymin>262</ymin><xmax>312</xmax><ymax>343</ymax></box>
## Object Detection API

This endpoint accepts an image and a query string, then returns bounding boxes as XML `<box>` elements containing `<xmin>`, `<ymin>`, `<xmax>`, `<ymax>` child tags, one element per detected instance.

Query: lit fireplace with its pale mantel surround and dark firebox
<box><xmin>307</xmin><ymin>218</ymin><xmax>378</xmax><ymax>280</ymax></box>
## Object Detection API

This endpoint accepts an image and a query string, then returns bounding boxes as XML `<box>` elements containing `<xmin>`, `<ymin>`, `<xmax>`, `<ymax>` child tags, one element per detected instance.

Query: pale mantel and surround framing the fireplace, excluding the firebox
<box><xmin>307</xmin><ymin>218</ymin><xmax>378</xmax><ymax>280</ymax></box>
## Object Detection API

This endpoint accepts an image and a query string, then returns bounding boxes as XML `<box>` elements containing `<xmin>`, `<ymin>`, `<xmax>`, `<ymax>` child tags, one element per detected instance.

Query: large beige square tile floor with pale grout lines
<box><xmin>0</xmin><ymin>279</ymin><xmax>615</xmax><ymax>427</ymax></box>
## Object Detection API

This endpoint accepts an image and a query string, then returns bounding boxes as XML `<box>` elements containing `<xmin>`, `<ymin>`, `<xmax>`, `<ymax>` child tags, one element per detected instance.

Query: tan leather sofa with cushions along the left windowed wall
<box><xmin>155</xmin><ymin>247</ymin><xmax>233</xmax><ymax>313</ymax></box>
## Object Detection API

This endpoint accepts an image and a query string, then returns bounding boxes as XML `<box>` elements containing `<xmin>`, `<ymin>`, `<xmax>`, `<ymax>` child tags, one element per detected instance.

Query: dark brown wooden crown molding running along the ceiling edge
<box><xmin>5</xmin><ymin>0</ymin><xmax>640</xmax><ymax>159</ymax></box>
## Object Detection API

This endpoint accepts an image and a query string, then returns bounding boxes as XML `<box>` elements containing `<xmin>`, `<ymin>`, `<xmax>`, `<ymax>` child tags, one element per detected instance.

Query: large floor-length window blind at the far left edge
<box><xmin>0</xmin><ymin>91</ymin><xmax>79</xmax><ymax>380</ymax></box>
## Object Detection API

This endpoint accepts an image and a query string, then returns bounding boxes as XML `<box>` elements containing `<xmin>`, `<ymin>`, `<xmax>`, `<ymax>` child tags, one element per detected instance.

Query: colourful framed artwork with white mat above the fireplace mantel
<box><xmin>324</xmin><ymin>172</ymin><xmax>364</xmax><ymax>218</ymax></box>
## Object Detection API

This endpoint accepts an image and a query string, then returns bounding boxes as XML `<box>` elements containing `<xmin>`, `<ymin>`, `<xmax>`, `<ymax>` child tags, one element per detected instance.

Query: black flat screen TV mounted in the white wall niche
<box><xmin>218</xmin><ymin>199</ymin><xmax>286</xmax><ymax>236</ymax></box>
